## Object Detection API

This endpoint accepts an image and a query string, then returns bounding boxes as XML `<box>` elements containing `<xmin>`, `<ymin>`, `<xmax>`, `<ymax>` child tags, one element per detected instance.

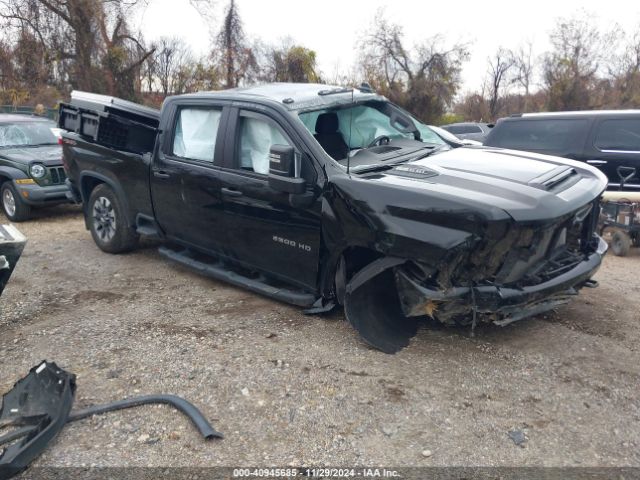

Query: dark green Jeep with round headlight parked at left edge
<box><xmin>0</xmin><ymin>114</ymin><xmax>69</xmax><ymax>222</ymax></box>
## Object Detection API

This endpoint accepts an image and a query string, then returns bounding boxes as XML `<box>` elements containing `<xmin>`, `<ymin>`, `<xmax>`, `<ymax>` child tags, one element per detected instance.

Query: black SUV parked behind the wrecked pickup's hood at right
<box><xmin>485</xmin><ymin>110</ymin><xmax>640</xmax><ymax>191</ymax></box>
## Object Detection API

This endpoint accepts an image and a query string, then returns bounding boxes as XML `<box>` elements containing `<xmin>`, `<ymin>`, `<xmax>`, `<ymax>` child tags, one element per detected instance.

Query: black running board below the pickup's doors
<box><xmin>158</xmin><ymin>246</ymin><xmax>316</xmax><ymax>307</ymax></box>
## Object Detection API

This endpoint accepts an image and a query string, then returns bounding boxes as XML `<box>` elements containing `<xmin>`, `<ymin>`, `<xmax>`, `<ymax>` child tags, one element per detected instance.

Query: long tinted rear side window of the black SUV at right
<box><xmin>485</xmin><ymin>119</ymin><xmax>589</xmax><ymax>152</ymax></box>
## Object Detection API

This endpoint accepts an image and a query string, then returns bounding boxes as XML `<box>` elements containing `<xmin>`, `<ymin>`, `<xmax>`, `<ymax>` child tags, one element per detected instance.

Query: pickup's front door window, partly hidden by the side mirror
<box><xmin>238</xmin><ymin>114</ymin><xmax>291</xmax><ymax>175</ymax></box>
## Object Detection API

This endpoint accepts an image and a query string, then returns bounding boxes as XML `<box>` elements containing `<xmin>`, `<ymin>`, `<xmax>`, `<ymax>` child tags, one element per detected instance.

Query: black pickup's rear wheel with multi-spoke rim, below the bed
<box><xmin>85</xmin><ymin>184</ymin><xmax>138</xmax><ymax>253</ymax></box>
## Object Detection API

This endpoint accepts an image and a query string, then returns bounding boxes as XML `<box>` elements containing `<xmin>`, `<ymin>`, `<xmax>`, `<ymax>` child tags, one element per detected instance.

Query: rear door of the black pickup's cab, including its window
<box><xmin>151</xmin><ymin>102</ymin><xmax>228</xmax><ymax>252</ymax></box>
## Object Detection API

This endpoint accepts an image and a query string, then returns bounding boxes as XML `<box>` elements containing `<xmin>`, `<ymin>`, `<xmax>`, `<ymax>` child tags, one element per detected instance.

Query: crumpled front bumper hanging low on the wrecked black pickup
<box><xmin>396</xmin><ymin>236</ymin><xmax>608</xmax><ymax>325</ymax></box>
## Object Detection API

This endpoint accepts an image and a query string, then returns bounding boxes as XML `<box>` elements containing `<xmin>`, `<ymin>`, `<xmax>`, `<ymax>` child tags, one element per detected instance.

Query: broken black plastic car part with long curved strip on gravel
<box><xmin>0</xmin><ymin>361</ymin><xmax>223</xmax><ymax>480</ymax></box>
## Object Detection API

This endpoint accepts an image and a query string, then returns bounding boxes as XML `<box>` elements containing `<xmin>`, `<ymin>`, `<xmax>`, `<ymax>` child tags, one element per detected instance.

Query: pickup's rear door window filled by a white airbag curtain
<box><xmin>173</xmin><ymin>107</ymin><xmax>222</xmax><ymax>163</ymax></box>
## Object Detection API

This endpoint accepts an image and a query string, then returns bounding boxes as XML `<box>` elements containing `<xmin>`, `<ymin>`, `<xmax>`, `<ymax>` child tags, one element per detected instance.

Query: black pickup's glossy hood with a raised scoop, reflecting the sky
<box><xmin>363</xmin><ymin>147</ymin><xmax>607</xmax><ymax>222</ymax></box>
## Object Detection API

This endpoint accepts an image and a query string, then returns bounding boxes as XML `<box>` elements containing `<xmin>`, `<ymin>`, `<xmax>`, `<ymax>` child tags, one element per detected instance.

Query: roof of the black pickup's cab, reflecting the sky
<box><xmin>175</xmin><ymin>83</ymin><xmax>385</xmax><ymax>110</ymax></box>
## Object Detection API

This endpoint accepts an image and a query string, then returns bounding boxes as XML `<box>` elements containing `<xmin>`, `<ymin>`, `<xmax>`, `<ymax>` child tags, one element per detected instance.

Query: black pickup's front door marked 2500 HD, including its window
<box><xmin>215</xmin><ymin>108</ymin><xmax>321</xmax><ymax>289</ymax></box>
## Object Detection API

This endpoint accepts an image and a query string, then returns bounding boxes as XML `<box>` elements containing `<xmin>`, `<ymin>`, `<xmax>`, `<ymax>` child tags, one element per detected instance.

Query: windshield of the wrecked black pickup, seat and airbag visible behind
<box><xmin>298</xmin><ymin>101</ymin><xmax>445</xmax><ymax>160</ymax></box>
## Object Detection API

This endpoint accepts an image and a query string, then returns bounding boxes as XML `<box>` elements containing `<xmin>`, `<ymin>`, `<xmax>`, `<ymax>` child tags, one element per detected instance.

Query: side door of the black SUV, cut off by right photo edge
<box><xmin>586</xmin><ymin>114</ymin><xmax>640</xmax><ymax>191</ymax></box>
